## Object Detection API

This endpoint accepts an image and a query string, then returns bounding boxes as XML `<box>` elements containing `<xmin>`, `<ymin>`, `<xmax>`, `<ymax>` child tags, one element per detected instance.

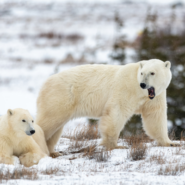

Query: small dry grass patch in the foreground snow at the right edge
<box><xmin>158</xmin><ymin>164</ymin><xmax>185</xmax><ymax>176</ymax></box>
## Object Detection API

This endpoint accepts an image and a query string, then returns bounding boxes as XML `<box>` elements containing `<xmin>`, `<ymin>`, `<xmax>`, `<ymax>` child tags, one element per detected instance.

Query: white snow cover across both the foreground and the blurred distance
<box><xmin>0</xmin><ymin>0</ymin><xmax>185</xmax><ymax>184</ymax></box>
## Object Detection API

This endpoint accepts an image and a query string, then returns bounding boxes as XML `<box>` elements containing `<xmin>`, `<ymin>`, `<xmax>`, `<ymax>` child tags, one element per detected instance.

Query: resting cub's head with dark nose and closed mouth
<box><xmin>7</xmin><ymin>109</ymin><xmax>35</xmax><ymax>136</ymax></box>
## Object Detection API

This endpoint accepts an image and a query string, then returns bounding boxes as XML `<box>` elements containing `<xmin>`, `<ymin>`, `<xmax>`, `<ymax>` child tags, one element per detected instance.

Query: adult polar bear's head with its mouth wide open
<box><xmin>137</xmin><ymin>59</ymin><xmax>172</xmax><ymax>99</ymax></box>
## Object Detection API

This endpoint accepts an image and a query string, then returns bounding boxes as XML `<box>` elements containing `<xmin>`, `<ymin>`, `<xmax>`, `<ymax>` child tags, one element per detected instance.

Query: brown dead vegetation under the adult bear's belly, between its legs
<box><xmin>63</xmin><ymin>125</ymin><xmax>111</xmax><ymax>162</ymax></box>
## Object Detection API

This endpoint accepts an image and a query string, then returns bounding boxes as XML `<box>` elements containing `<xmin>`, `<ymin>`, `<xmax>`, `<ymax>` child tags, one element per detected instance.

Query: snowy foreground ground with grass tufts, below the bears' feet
<box><xmin>0</xmin><ymin>138</ymin><xmax>185</xmax><ymax>185</ymax></box>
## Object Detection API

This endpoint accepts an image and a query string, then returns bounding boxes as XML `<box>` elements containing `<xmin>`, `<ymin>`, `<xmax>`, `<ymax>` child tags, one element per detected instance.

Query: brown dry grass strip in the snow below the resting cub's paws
<box><xmin>0</xmin><ymin>167</ymin><xmax>39</xmax><ymax>183</ymax></box>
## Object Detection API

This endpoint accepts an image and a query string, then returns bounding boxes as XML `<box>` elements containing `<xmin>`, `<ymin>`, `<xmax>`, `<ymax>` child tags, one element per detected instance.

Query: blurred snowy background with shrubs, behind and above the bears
<box><xmin>0</xmin><ymin>0</ymin><xmax>185</xmax><ymax>136</ymax></box>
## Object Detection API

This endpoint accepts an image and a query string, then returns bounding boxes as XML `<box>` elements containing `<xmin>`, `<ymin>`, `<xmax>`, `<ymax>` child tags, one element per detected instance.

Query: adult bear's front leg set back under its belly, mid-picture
<box><xmin>99</xmin><ymin>106</ymin><xmax>130</xmax><ymax>150</ymax></box>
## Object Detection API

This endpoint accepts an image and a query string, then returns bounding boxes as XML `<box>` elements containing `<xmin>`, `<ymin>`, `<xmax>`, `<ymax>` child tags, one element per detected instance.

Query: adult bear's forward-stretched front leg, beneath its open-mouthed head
<box><xmin>142</xmin><ymin>92</ymin><xmax>180</xmax><ymax>146</ymax></box>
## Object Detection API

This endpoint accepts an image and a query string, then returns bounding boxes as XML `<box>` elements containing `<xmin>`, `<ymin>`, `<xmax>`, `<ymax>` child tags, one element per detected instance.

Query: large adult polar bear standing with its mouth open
<box><xmin>36</xmin><ymin>59</ymin><xmax>177</xmax><ymax>153</ymax></box>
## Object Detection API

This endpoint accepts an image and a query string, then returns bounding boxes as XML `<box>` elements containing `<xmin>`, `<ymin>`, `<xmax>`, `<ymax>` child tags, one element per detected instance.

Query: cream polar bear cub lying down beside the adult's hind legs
<box><xmin>0</xmin><ymin>109</ymin><xmax>47</xmax><ymax>167</ymax></box>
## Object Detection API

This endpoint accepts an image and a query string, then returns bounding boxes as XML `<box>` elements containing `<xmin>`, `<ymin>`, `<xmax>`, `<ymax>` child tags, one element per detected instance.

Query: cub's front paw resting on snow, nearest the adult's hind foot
<box><xmin>19</xmin><ymin>152</ymin><xmax>46</xmax><ymax>167</ymax></box>
